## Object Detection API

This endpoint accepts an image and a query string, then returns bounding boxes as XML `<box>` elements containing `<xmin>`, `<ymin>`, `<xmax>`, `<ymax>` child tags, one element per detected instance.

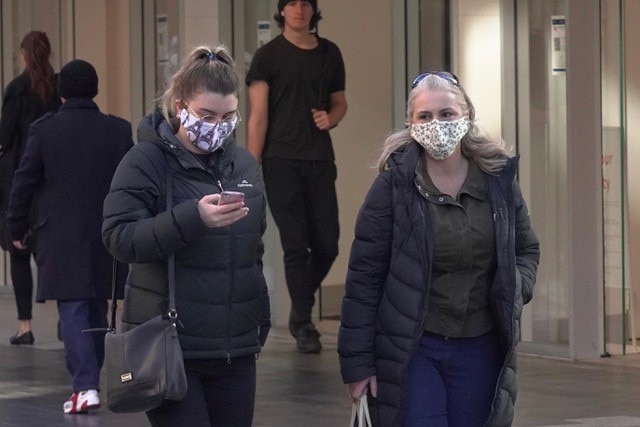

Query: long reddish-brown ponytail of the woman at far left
<box><xmin>20</xmin><ymin>31</ymin><xmax>55</xmax><ymax>102</ymax></box>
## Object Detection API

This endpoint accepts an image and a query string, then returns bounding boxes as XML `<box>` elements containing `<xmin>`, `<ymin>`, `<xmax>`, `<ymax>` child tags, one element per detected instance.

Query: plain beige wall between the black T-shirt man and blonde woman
<box><xmin>320</xmin><ymin>0</ymin><xmax>393</xmax><ymax>294</ymax></box>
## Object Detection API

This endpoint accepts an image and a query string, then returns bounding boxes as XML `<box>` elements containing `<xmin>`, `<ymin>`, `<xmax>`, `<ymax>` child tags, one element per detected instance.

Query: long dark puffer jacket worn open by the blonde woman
<box><xmin>338</xmin><ymin>143</ymin><xmax>540</xmax><ymax>427</ymax></box>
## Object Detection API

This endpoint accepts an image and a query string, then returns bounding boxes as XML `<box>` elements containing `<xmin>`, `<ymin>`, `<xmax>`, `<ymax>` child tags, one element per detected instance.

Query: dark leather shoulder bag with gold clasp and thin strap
<box><xmin>105</xmin><ymin>171</ymin><xmax>187</xmax><ymax>413</ymax></box>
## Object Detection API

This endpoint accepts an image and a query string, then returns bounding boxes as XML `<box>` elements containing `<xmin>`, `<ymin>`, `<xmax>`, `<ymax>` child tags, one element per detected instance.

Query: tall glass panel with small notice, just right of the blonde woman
<box><xmin>518</xmin><ymin>0</ymin><xmax>571</xmax><ymax>355</ymax></box>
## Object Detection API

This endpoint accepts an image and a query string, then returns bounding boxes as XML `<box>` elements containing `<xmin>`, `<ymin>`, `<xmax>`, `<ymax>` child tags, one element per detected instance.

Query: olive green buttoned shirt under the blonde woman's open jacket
<box><xmin>415</xmin><ymin>158</ymin><xmax>496</xmax><ymax>338</ymax></box>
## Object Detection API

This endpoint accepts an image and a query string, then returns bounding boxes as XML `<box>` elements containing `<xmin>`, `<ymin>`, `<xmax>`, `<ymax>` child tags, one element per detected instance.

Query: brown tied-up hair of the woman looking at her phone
<box><xmin>156</xmin><ymin>46</ymin><xmax>240</xmax><ymax>130</ymax></box>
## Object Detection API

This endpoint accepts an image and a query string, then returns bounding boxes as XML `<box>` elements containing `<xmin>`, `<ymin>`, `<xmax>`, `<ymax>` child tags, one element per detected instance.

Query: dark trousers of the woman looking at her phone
<box><xmin>147</xmin><ymin>355</ymin><xmax>256</xmax><ymax>427</ymax></box>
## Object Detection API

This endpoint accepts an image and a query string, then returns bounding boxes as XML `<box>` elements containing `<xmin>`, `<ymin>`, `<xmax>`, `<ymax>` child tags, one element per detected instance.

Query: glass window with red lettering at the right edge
<box><xmin>601</xmin><ymin>0</ymin><xmax>640</xmax><ymax>354</ymax></box>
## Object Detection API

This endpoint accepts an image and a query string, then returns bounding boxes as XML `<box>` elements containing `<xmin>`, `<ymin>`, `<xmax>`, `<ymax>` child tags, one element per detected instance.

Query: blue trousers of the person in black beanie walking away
<box><xmin>58</xmin><ymin>299</ymin><xmax>108</xmax><ymax>393</ymax></box>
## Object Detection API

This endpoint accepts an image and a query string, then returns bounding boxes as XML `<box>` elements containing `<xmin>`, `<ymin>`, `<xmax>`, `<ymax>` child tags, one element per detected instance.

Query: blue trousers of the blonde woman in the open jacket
<box><xmin>402</xmin><ymin>332</ymin><xmax>502</xmax><ymax>427</ymax></box>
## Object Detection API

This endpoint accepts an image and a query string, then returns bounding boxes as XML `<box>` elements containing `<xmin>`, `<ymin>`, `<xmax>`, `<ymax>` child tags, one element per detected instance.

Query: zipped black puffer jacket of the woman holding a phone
<box><xmin>102</xmin><ymin>112</ymin><xmax>271</xmax><ymax>359</ymax></box>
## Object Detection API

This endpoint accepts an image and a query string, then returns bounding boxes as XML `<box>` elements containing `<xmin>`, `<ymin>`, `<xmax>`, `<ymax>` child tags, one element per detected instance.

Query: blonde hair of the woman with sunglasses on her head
<box><xmin>376</xmin><ymin>74</ymin><xmax>508</xmax><ymax>174</ymax></box>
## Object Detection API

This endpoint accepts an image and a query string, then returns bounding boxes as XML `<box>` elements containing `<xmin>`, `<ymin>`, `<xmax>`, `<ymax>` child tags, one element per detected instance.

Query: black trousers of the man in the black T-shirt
<box><xmin>262</xmin><ymin>158</ymin><xmax>340</xmax><ymax>325</ymax></box>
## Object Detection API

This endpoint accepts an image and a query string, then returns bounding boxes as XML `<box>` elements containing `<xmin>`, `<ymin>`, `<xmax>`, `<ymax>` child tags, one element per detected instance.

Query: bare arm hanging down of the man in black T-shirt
<box><xmin>247</xmin><ymin>80</ymin><xmax>269</xmax><ymax>163</ymax></box>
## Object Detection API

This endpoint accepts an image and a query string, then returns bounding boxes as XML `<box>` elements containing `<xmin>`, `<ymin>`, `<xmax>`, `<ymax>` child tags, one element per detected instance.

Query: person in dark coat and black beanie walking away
<box><xmin>7</xmin><ymin>60</ymin><xmax>133</xmax><ymax>414</ymax></box>
